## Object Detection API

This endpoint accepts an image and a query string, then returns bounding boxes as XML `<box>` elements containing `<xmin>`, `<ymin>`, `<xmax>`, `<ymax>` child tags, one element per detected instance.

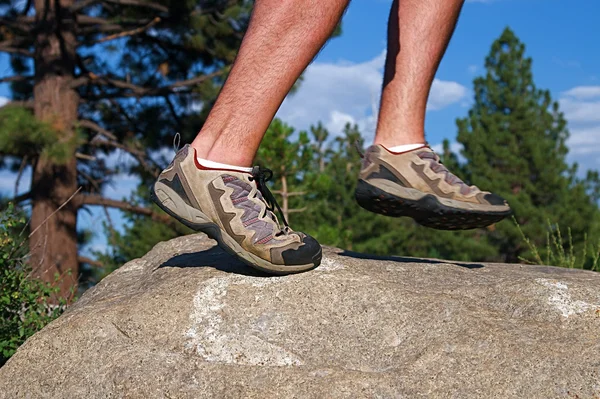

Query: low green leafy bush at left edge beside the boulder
<box><xmin>0</xmin><ymin>204</ymin><xmax>64</xmax><ymax>366</ymax></box>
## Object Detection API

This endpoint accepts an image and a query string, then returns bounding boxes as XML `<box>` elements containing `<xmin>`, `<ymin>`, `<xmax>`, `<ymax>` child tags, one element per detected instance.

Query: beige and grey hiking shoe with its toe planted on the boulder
<box><xmin>151</xmin><ymin>145</ymin><xmax>321</xmax><ymax>274</ymax></box>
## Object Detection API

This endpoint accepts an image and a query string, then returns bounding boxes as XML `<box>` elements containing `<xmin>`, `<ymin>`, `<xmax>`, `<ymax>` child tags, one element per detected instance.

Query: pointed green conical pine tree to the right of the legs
<box><xmin>457</xmin><ymin>28</ymin><xmax>598</xmax><ymax>262</ymax></box>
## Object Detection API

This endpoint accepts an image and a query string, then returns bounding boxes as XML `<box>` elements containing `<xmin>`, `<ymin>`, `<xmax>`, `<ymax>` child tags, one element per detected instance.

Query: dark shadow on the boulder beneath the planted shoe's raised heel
<box><xmin>158</xmin><ymin>245</ymin><xmax>273</xmax><ymax>277</ymax></box>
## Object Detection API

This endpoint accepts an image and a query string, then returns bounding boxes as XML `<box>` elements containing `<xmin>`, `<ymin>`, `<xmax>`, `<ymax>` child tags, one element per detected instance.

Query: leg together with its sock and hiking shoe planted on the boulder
<box><xmin>151</xmin><ymin>0</ymin><xmax>349</xmax><ymax>274</ymax></box>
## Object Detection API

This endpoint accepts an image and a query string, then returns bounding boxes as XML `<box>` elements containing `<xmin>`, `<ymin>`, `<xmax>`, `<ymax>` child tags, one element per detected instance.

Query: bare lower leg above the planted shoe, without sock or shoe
<box><xmin>192</xmin><ymin>0</ymin><xmax>349</xmax><ymax>166</ymax></box>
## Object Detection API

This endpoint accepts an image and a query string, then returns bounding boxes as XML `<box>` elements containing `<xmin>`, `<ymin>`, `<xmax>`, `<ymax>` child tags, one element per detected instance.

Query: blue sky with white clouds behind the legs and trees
<box><xmin>0</xmin><ymin>0</ymin><xmax>600</xmax><ymax>256</ymax></box>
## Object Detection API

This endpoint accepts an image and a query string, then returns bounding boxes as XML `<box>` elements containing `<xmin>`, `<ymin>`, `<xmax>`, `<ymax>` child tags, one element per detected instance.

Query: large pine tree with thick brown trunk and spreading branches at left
<box><xmin>0</xmin><ymin>0</ymin><xmax>251</xmax><ymax>300</ymax></box>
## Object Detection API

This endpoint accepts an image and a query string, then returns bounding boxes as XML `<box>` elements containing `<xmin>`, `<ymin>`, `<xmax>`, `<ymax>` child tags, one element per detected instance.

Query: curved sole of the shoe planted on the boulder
<box><xmin>150</xmin><ymin>182</ymin><xmax>322</xmax><ymax>275</ymax></box>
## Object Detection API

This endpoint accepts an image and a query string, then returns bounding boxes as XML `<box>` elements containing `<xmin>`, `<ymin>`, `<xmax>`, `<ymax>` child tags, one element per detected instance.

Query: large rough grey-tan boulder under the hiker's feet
<box><xmin>0</xmin><ymin>235</ymin><xmax>600</xmax><ymax>398</ymax></box>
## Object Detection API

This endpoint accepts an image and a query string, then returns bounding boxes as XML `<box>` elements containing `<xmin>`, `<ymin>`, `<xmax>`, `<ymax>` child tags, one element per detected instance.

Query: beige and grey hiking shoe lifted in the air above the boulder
<box><xmin>355</xmin><ymin>145</ymin><xmax>512</xmax><ymax>230</ymax></box>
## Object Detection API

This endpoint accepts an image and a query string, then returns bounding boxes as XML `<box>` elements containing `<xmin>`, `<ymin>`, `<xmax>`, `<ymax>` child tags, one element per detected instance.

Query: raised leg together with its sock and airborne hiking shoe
<box><xmin>356</xmin><ymin>0</ymin><xmax>511</xmax><ymax>230</ymax></box>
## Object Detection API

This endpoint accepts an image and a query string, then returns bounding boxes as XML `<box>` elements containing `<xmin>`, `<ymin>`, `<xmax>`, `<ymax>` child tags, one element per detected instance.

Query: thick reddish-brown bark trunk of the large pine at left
<box><xmin>30</xmin><ymin>0</ymin><xmax>79</xmax><ymax>299</ymax></box>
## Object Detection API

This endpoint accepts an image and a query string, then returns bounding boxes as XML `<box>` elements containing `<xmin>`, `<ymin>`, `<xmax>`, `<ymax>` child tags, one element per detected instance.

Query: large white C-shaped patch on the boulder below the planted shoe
<box><xmin>185</xmin><ymin>276</ymin><xmax>303</xmax><ymax>366</ymax></box>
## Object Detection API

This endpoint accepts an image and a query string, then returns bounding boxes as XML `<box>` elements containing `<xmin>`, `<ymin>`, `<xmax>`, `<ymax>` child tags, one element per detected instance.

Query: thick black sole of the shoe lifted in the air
<box><xmin>355</xmin><ymin>180</ymin><xmax>512</xmax><ymax>230</ymax></box>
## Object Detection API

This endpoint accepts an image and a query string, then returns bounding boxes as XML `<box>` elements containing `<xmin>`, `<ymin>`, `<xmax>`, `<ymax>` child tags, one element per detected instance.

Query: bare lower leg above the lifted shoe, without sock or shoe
<box><xmin>375</xmin><ymin>0</ymin><xmax>463</xmax><ymax>147</ymax></box>
